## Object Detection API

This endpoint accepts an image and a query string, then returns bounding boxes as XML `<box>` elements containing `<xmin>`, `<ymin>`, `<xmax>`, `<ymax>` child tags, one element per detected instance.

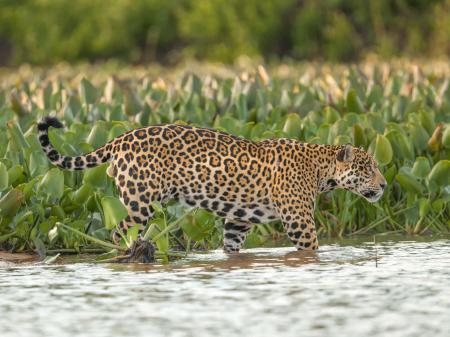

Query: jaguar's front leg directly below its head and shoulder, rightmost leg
<box><xmin>277</xmin><ymin>200</ymin><xmax>319</xmax><ymax>250</ymax></box>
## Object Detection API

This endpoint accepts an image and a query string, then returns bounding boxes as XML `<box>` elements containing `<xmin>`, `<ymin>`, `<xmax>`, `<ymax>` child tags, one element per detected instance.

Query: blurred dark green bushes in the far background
<box><xmin>0</xmin><ymin>0</ymin><xmax>450</xmax><ymax>64</ymax></box>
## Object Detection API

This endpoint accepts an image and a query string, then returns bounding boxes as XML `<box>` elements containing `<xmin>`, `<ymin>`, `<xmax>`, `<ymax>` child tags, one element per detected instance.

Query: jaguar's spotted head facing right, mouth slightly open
<box><xmin>333</xmin><ymin>145</ymin><xmax>387</xmax><ymax>202</ymax></box>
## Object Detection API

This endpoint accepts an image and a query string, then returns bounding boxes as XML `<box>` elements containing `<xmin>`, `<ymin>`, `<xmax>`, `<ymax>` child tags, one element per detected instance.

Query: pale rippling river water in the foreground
<box><xmin>0</xmin><ymin>238</ymin><xmax>450</xmax><ymax>337</ymax></box>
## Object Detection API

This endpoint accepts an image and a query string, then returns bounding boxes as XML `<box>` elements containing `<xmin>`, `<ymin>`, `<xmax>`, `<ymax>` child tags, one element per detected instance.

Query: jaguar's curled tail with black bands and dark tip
<box><xmin>37</xmin><ymin>117</ymin><xmax>112</xmax><ymax>170</ymax></box>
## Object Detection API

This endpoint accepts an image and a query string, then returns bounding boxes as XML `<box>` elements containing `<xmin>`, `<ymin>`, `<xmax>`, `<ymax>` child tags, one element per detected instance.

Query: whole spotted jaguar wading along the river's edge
<box><xmin>38</xmin><ymin>117</ymin><xmax>386</xmax><ymax>252</ymax></box>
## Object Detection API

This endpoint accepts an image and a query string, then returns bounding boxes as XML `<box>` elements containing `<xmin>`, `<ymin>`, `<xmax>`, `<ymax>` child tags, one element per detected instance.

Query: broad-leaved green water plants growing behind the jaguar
<box><xmin>0</xmin><ymin>64</ymin><xmax>450</xmax><ymax>255</ymax></box>
